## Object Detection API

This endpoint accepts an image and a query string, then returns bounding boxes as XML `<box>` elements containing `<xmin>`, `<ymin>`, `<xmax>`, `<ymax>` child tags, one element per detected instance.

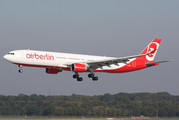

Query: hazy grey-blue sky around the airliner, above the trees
<box><xmin>0</xmin><ymin>0</ymin><xmax>179</xmax><ymax>95</ymax></box>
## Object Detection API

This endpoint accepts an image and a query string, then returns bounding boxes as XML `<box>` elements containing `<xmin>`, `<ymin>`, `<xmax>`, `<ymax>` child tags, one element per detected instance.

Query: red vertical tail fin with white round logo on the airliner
<box><xmin>141</xmin><ymin>39</ymin><xmax>161</xmax><ymax>61</ymax></box>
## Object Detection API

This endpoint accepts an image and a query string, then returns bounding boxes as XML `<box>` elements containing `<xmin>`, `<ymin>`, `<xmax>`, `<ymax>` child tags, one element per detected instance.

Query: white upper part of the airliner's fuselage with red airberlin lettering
<box><xmin>4</xmin><ymin>50</ymin><xmax>129</xmax><ymax>70</ymax></box>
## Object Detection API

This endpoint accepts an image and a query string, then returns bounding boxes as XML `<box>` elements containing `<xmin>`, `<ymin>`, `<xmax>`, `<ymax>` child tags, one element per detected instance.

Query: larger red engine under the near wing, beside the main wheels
<box><xmin>71</xmin><ymin>63</ymin><xmax>87</xmax><ymax>72</ymax></box>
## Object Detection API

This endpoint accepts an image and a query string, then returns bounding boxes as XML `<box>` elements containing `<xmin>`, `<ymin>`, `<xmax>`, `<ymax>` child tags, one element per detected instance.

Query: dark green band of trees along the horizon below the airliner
<box><xmin>0</xmin><ymin>92</ymin><xmax>179</xmax><ymax>117</ymax></box>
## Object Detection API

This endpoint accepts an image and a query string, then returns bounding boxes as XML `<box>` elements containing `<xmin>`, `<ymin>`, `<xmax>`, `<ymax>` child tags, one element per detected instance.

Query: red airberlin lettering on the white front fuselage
<box><xmin>26</xmin><ymin>53</ymin><xmax>54</xmax><ymax>60</ymax></box>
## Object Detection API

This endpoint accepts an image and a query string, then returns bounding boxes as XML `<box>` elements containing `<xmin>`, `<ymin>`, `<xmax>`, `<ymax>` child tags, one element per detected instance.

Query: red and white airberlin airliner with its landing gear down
<box><xmin>4</xmin><ymin>38</ymin><xmax>170</xmax><ymax>81</ymax></box>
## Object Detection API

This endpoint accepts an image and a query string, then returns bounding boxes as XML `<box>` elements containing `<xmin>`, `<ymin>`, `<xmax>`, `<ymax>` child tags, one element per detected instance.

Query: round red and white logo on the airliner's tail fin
<box><xmin>146</xmin><ymin>42</ymin><xmax>159</xmax><ymax>61</ymax></box>
